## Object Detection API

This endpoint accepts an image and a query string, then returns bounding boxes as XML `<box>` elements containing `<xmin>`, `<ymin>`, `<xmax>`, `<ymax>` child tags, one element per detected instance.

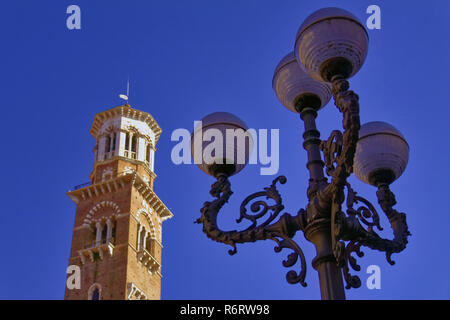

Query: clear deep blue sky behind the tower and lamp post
<box><xmin>0</xmin><ymin>0</ymin><xmax>450</xmax><ymax>299</ymax></box>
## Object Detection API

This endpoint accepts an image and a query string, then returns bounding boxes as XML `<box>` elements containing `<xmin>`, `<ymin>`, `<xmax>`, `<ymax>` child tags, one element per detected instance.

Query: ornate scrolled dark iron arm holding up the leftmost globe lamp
<box><xmin>195</xmin><ymin>175</ymin><xmax>306</xmax><ymax>286</ymax></box>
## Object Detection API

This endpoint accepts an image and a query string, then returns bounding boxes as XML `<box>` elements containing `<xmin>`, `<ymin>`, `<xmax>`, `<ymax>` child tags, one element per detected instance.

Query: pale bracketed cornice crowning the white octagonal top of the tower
<box><xmin>89</xmin><ymin>103</ymin><xmax>162</xmax><ymax>144</ymax></box>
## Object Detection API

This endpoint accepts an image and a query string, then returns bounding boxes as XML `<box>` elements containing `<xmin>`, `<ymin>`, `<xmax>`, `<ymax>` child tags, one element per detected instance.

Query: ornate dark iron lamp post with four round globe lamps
<box><xmin>193</xmin><ymin>8</ymin><xmax>410</xmax><ymax>299</ymax></box>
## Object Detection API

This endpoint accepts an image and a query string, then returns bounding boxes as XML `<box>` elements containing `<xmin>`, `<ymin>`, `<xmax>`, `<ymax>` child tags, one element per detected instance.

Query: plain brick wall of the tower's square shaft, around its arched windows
<box><xmin>65</xmin><ymin>178</ymin><xmax>161</xmax><ymax>300</ymax></box>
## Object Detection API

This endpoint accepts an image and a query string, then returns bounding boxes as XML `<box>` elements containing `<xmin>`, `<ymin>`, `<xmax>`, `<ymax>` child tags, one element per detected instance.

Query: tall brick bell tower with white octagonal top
<box><xmin>65</xmin><ymin>104</ymin><xmax>173</xmax><ymax>300</ymax></box>
